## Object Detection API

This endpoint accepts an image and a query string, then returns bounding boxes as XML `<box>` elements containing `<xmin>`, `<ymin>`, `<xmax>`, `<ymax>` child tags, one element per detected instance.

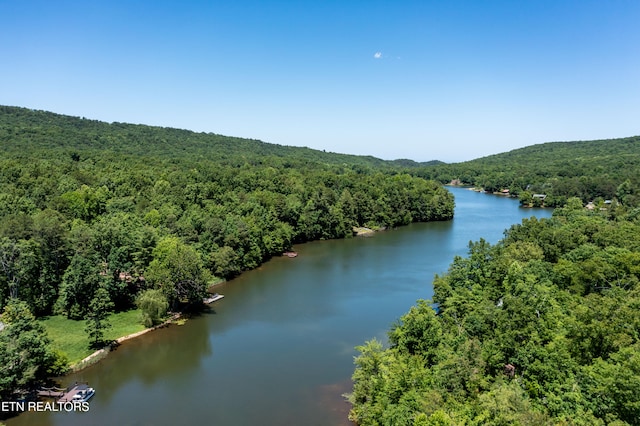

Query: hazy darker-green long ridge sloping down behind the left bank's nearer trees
<box><xmin>0</xmin><ymin>106</ymin><xmax>441</xmax><ymax>168</ymax></box>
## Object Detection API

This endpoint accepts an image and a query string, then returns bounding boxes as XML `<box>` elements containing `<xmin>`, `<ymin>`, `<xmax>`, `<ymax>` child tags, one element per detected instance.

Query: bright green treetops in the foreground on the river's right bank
<box><xmin>349</xmin><ymin>203</ymin><xmax>640</xmax><ymax>426</ymax></box>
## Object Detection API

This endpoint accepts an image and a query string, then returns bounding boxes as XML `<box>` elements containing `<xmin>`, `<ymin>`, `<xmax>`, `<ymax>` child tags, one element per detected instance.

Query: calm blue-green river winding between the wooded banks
<box><xmin>8</xmin><ymin>188</ymin><xmax>551</xmax><ymax>426</ymax></box>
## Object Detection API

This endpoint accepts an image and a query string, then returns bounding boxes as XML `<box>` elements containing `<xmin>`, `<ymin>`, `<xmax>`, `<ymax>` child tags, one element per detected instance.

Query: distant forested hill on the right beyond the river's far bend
<box><xmin>422</xmin><ymin>136</ymin><xmax>640</xmax><ymax>206</ymax></box>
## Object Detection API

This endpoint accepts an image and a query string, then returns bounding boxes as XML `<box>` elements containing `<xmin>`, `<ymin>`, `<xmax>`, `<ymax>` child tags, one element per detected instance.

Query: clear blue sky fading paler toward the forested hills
<box><xmin>0</xmin><ymin>0</ymin><xmax>640</xmax><ymax>162</ymax></box>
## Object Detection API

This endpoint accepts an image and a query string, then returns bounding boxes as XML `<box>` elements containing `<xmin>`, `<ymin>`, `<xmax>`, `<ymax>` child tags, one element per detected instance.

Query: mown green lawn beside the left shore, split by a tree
<box><xmin>40</xmin><ymin>309</ymin><xmax>145</xmax><ymax>364</ymax></box>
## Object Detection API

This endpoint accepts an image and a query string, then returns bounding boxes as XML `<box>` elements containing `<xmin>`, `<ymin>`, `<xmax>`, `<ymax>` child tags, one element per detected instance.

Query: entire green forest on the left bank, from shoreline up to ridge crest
<box><xmin>0</xmin><ymin>107</ymin><xmax>453</xmax><ymax>398</ymax></box>
